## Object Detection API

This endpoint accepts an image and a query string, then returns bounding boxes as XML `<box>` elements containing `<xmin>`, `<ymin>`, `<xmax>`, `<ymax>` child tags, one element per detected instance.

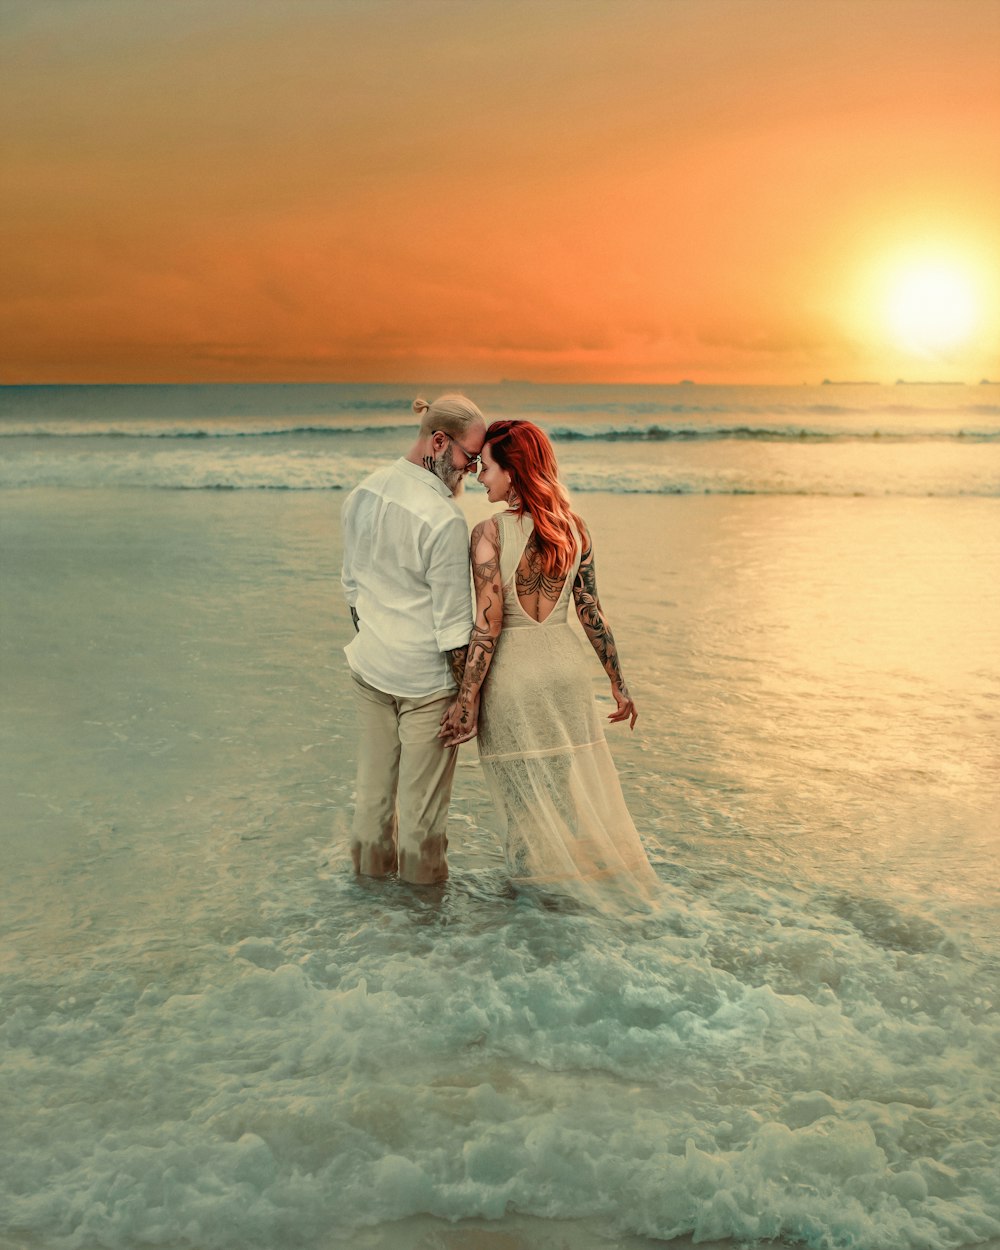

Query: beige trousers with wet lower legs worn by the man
<box><xmin>351</xmin><ymin>673</ymin><xmax>459</xmax><ymax>885</ymax></box>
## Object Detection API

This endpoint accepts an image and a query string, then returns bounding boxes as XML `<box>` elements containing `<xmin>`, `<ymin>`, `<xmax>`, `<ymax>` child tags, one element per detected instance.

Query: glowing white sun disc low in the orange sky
<box><xmin>884</xmin><ymin>258</ymin><xmax>979</xmax><ymax>356</ymax></box>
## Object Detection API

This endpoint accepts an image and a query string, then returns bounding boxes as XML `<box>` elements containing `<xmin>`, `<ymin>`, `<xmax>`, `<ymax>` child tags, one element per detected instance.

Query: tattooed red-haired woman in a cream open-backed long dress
<box><xmin>441</xmin><ymin>421</ymin><xmax>656</xmax><ymax>904</ymax></box>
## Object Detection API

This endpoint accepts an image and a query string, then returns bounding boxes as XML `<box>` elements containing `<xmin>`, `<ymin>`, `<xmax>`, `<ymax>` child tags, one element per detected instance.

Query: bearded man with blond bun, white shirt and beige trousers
<box><xmin>341</xmin><ymin>395</ymin><xmax>486</xmax><ymax>885</ymax></box>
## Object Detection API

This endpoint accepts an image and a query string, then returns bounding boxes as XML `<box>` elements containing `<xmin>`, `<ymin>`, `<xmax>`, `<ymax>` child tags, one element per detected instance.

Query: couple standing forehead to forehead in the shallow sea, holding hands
<box><xmin>343</xmin><ymin>395</ymin><xmax>655</xmax><ymax>901</ymax></box>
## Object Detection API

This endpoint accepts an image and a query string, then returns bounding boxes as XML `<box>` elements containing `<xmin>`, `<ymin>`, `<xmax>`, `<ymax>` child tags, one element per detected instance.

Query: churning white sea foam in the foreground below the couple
<box><xmin>3</xmin><ymin>876</ymin><xmax>1000</xmax><ymax>1250</ymax></box>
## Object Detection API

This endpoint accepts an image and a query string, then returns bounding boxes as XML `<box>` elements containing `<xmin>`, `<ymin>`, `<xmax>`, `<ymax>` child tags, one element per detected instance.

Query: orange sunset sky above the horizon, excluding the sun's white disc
<box><xmin>0</xmin><ymin>0</ymin><xmax>1000</xmax><ymax>383</ymax></box>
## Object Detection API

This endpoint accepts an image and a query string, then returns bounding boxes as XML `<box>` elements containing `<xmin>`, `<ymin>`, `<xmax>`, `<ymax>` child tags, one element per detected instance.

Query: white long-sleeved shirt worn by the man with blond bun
<box><xmin>341</xmin><ymin>459</ymin><xmax>473</xmax><ymax>698</ymax></box>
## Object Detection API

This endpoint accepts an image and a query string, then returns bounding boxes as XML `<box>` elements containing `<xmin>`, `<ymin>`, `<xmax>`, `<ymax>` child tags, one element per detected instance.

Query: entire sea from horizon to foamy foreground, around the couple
<box><xmin>0</xmin><ymin>384</ymin><xmax>1000</xmax><ymax>1250</ymax></box>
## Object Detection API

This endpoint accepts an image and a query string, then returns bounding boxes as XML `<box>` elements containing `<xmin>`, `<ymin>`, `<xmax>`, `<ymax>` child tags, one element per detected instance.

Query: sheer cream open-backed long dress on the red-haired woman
<box><xmin>479</xmin><ymin>513</ymin><xmax>656</xmax><ymax>905</ymax></box>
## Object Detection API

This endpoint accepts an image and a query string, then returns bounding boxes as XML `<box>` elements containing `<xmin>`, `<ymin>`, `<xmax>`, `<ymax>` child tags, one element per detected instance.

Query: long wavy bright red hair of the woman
<box><xmin>486</xmin><ymin>421</ymin><xmax>584</xmax><ymax>578</ymax></box>
